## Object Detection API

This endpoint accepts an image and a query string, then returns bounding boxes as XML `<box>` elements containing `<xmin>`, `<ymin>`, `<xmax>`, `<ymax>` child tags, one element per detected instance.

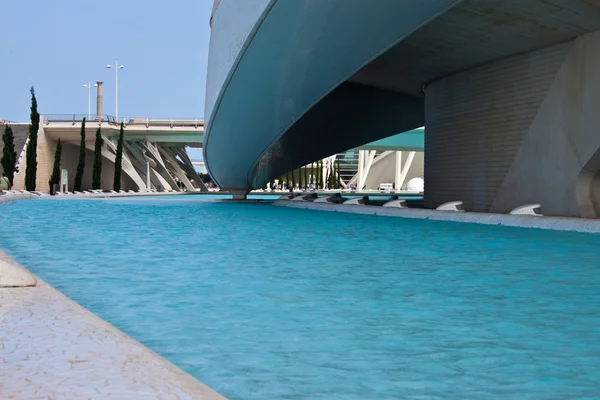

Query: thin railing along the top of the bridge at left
<box><xmin>44</xmin><ymin>114</ymin><xmax>204</xmax><ymax>129</ymax></box>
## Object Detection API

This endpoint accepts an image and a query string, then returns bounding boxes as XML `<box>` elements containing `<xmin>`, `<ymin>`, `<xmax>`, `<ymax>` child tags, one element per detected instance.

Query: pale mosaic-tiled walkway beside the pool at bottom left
<box><xmin>0</xmin><ymin>252</ymin><xmax>224</xmax><ymax>400</ymax></box>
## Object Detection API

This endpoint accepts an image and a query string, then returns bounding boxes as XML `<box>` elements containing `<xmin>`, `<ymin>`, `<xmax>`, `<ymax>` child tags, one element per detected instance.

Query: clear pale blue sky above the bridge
<box><xmin>0</xmin><ymin>0</ymin><xmax>212</xmax><ymax>122</ymax></box>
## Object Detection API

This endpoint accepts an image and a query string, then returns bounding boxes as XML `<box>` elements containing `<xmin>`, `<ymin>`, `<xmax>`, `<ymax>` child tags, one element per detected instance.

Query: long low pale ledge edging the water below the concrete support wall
<box><xmin>273</xmin><ymin>200</ymin><xmax>600</xmax><ymax>233</ymax></box>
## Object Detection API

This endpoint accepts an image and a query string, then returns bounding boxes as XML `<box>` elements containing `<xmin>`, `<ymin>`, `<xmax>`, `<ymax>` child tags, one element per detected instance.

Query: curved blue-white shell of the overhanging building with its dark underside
<box><xmin>204</xmin><ymin>0</ymin><xmax>460</xmax><ymax>191</ymax></box>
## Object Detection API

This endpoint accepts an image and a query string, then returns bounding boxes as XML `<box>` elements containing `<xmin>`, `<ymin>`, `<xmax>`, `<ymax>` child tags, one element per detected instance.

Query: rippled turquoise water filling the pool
<box><xmin>0</xmin><ymin>197</ymin><xmax>600</xmax><ymax>400</ymax></box>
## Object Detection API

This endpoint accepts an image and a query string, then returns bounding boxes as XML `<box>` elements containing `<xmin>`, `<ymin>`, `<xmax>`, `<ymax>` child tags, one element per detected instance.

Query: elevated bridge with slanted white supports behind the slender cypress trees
<box><xmin>14</xmin><ymin>114</ymin><xmax>207</xmax><ymax>191</ymax></box>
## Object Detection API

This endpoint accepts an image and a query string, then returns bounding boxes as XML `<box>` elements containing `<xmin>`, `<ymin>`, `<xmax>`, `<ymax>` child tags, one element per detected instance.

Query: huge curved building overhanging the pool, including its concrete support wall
<box><xmin>204</xmin><ymin>0</ymin><xmax>600</xmax><ymax>217</ymax></box>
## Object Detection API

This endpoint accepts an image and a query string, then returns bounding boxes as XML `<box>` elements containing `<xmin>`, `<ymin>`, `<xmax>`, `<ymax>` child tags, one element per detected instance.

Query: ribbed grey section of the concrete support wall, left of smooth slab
<box><xmin>425</xmin><ymin>43</ymin><xmax>572</xmax><ymax>211</ymax></box>
